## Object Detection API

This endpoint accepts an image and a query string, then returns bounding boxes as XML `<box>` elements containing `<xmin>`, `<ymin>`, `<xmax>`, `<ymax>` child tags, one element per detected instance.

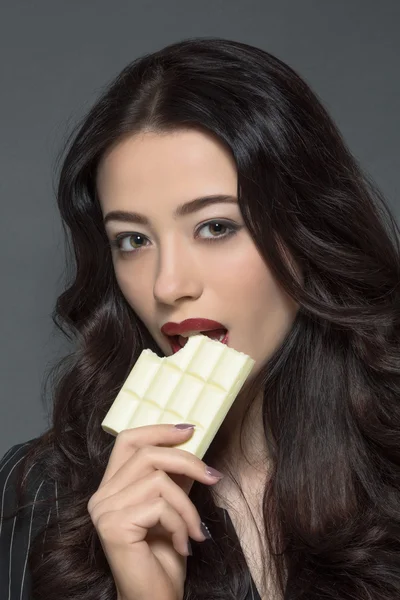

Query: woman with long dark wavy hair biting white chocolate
<box><xmin>0</xmin><ymin>39</ymin><xmax>400</xmax><ymax>600</ymax></box>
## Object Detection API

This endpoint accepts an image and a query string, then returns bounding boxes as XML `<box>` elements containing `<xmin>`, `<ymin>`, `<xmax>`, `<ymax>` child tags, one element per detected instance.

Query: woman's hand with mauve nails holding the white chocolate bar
<box><xmin>88</xmin><ymin>425</ymin><xmax>223</xmax><ymax>600</ymax></box>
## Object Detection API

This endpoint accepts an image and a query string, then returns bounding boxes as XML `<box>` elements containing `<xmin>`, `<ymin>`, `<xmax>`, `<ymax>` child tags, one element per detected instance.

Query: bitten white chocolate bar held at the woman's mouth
<box><xmin>101</xmin><ymin>334</ymin><xmax>255</xmax><ymax>459</ymax></box>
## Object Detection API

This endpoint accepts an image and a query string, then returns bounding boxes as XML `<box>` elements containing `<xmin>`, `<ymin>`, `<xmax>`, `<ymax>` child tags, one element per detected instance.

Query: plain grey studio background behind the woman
<box><xmin>0</xmin><ymin>0</ymin><xmax>400</xmax><ymax>456</ymax></box>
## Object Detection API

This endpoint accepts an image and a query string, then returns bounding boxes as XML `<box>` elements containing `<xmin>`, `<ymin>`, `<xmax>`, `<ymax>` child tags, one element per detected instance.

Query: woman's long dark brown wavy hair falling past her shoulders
<box><xmin>5</xmin><ymin>38</ymin><xmax>400</xmax><ymax>600</ymax></box>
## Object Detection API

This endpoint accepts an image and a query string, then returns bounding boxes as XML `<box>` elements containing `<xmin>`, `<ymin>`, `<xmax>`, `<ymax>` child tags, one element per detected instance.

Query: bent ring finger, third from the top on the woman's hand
<box><xmin>90</xmin><ymin>471</ymin><xmax>206</xmax><ymax>542</ymax></box>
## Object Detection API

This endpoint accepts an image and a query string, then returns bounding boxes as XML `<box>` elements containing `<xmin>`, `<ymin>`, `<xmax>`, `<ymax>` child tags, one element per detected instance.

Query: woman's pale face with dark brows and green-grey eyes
<box><xmin>97</xmin><ymin>130</ymin><xmax>297</xmax><ymax>374</ymax></box>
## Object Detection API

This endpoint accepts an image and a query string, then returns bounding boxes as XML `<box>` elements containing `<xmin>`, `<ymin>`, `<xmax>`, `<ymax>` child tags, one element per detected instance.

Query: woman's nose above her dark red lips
<box><xmin>153</xmin><ymin>240</ymin><xmax>203</xmax><ymax>305</ymax></box>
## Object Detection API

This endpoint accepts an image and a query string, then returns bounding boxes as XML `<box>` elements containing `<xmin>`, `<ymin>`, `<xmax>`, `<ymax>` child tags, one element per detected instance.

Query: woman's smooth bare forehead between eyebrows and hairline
<box><xmin>97</xmin><ymin>129</ymin><xmax>237</xmax><ymax>202</ymax></box>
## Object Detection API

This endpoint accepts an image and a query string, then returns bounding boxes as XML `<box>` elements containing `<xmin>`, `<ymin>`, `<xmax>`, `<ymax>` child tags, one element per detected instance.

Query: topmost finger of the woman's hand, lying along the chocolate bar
<box><xmin>100</xmin><ymin>424</ymin><xmax>193</xmax><ymax>485</ymax></box>
